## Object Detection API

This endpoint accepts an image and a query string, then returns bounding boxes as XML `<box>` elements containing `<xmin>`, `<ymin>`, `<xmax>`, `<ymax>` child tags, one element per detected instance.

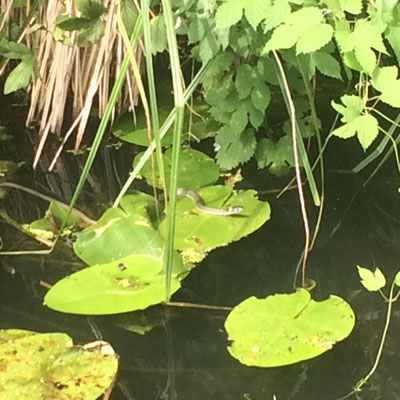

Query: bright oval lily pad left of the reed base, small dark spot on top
<box><xmin>44</xmin><ymin>255</ymin><xmax>180</xmax><ymax>315</ymax></box>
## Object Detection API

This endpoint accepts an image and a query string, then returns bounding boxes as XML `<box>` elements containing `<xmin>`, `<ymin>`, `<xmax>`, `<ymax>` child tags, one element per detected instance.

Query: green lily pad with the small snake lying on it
<box><xmin>160</xmin><ymin>186</ymin><xmax>270</xmax><ymax>254</ymax></box>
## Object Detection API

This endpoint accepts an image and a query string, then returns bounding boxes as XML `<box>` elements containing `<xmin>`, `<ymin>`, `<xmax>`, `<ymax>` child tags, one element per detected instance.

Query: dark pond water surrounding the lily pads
<box><xmin>0</xmin><ymin>104</ymin><xmax>400</xmax><ymax>400</ymax></box>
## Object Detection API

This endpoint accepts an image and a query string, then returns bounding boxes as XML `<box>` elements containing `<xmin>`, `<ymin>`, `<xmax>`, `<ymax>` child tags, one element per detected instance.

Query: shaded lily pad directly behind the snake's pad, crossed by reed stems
<box><xmin>133</xmin><ymin>147</ymin><xmax>220</xmax><ymax>189</ymax></box>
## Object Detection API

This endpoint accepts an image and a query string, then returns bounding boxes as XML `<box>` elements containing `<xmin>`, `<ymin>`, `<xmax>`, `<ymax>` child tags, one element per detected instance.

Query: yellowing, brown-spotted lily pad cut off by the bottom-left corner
<box><xmin>0</xmin><ymin>330</ymin><xmax>118</xmax><ymax>400</ymax></box>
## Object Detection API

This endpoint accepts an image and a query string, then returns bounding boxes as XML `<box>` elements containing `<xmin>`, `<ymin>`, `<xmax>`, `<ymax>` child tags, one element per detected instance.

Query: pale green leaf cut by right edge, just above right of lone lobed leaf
<box><xmin>371</xmin><ymin>65</ymin><xmax>400</xmax><ymax>107</ymax></box>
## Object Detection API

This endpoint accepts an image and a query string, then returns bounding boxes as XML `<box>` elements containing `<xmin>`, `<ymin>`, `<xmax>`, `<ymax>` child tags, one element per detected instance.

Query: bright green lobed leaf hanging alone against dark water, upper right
<box><xmin>332</xmin><ymin>95</ymin><xmax>379</xmax><ymax>150</ymax></box>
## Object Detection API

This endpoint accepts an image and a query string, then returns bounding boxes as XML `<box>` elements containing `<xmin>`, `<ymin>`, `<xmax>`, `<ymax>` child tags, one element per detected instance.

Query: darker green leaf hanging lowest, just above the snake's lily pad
<box><xmin>215</xmin><ymin>126</ymin><xmax>257</xmax><ymax>169</ymax></box>
